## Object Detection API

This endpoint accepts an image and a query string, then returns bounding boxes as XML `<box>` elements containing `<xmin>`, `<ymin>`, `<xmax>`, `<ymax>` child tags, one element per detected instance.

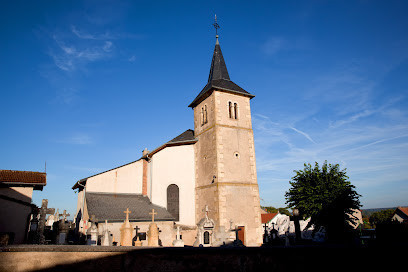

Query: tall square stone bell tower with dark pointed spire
<box><xmin>189</xmin><ymin>23</ymin><xmax>262</xmax><ymax>246</ymax></box>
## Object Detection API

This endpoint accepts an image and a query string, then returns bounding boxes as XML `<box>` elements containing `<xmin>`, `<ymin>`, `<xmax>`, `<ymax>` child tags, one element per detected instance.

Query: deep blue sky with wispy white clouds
<box><xmin>0</xmin><ymin>1</ymin><xmax>408</xmax><ymax>215</ymax></box>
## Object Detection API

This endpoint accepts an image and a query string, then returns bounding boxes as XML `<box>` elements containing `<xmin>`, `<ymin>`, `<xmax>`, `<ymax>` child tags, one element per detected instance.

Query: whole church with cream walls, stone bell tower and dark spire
<box><xmin>72</xmin><ymin>35</ymin><xmax>263</xmax><ymax>246</ymax></box>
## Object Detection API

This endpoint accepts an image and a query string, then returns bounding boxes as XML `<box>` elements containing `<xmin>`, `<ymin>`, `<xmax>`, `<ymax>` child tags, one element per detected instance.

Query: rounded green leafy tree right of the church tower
<box><xmin>285</xmin><ymin>161</ymin><xmax>361</xmax><ymax>241</ymax></box>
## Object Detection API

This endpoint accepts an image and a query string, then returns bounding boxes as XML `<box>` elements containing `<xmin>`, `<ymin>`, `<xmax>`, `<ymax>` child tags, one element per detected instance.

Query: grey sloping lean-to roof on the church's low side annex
<box><xmin>86</xmin><ymin>192</ymin><xmax>174</xmax><ymax>222</ymax></box>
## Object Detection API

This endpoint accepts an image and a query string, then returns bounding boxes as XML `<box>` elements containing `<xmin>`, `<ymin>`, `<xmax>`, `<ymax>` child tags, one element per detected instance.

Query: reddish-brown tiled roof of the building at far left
<box><xmin>0</xmin><ymin>170</ymin><xmax>47</xmax><ymax>185</ymax></box>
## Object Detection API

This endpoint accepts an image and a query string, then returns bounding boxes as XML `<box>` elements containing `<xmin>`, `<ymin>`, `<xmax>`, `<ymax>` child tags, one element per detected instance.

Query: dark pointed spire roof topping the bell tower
<box><xmin>189</xmin><ymin>42</ymin><xmax>255</xmax><ymax>108</ymax></box>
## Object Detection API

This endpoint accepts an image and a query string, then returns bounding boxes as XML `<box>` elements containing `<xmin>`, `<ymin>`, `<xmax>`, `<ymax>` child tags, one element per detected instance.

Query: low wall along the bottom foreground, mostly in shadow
<box><xmin>0</xmin><ymin>246</ymin><xmax>407</xmax><ymax>272</ymax></box>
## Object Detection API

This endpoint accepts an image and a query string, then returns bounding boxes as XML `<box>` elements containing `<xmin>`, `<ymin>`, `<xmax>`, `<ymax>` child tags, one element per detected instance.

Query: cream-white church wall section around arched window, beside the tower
<box><xmin>148</xmin><ymin>144</ymin><xmax>195</xmax><ymax>226</ymax></box>
